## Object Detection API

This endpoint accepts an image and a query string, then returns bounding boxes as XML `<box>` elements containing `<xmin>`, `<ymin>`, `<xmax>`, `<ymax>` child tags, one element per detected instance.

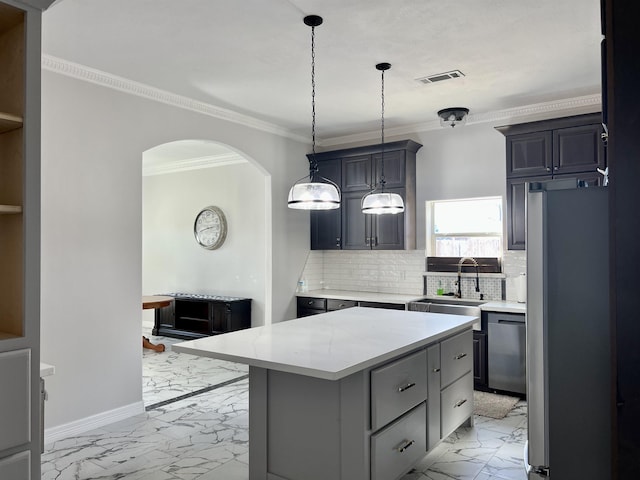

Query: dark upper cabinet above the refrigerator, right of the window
<box><xmin>497</xmin><ymin>113</ymin><xmax>606</xmax><ymax>250</ymax></box>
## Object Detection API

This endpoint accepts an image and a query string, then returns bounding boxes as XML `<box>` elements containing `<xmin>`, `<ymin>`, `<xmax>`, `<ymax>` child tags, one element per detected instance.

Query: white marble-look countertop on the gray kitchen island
<box><xmin>171</xmin><ymin>307</ymin><xmax>477</xmax><ymax>380</ymax></box>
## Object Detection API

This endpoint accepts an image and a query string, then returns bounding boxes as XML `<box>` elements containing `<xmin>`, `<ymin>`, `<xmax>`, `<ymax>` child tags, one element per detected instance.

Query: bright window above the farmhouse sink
<box><xmin>427</xmin><ymin>197</ymin><xmax>502</xmax><ymax>257</ymax></box>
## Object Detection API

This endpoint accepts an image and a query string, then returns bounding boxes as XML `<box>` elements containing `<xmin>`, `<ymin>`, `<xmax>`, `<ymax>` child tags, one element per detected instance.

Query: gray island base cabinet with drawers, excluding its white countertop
<box><xmin>249</xmin><ymin>329</ymin><xmax>473</xmax><ymax>480</ymax></box>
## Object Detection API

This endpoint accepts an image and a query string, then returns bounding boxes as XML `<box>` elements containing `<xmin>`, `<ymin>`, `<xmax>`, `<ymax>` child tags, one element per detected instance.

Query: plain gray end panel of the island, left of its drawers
<box><xmin>249</xmin><ymin>366</ymin><xmax>370</xmax><ymax>480</ymax></box>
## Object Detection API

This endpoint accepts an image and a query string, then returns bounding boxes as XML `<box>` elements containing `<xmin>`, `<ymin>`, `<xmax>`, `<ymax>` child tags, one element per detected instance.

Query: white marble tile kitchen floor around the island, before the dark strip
<box><xmin>42</xmin><ymin>378</ymin><xmax>526</xmax><ymax>480</ymax></box>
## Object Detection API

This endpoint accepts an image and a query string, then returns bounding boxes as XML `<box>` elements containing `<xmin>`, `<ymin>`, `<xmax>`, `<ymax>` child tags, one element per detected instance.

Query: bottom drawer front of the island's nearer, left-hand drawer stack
<box><xmin>371</xmin><ymin>403</ymin><xmax>427</xmax><ymax>480</ymax></box>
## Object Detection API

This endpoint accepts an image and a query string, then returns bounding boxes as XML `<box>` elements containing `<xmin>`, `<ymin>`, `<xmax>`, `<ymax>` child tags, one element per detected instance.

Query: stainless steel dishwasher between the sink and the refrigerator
<box><xmin>487</xmin><ymin>313</ymin><xmax>527</xmax><ymax>394</ymax></box>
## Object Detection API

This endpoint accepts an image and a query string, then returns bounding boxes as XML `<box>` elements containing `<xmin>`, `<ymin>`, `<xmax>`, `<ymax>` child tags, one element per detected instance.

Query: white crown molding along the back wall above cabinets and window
<box><xmin>318</xmin><ymin>94</ymin><xmax>602</xmax><ymax>147</ymax></box>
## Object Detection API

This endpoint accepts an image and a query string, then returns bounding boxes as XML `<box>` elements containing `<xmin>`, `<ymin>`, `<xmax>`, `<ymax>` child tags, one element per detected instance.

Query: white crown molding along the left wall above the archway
<box><xmin>42</xmin><ymin>54</ymin><xmax>309</xmax><ymax>143</ymax></box>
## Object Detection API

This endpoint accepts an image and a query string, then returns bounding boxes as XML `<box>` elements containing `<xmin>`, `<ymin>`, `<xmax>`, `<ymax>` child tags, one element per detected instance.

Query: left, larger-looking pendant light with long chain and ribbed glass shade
<box><xmin>288</xmin><ymin>15</ymin><xmax>340</xmax><ymax>210</ymax></box>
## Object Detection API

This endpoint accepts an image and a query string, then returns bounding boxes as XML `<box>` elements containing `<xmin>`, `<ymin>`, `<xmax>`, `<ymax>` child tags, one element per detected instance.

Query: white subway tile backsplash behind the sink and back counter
<box><xmin>300</xmin><ymin>250</ymin><xmax>526</xmax><ymax>301</ymax></box>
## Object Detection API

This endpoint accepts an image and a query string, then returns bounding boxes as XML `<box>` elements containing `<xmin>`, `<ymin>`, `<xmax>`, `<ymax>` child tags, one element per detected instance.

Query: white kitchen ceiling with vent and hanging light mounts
<box><xmin>43</xmin><ymin>0</ymin><xmax>601</xmax><ymax>140</ymax></box>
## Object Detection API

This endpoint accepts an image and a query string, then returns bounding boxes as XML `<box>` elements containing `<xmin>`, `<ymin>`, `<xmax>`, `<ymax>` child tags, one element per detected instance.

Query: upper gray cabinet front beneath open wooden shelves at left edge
<box><xmin>0</xmin><ymin>350</ymin><xmax>31</xmax><ymax>452</ymax></box>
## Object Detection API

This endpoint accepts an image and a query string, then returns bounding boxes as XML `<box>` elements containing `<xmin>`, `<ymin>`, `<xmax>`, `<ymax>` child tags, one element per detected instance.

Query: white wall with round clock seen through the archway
<box><xmin>142</xmin><ymin>163</ymin><xmax>268</xmax><ymax>326</ymax></box>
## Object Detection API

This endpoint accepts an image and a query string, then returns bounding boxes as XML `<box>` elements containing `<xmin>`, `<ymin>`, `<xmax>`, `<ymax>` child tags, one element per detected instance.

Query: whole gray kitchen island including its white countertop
<box><xmin>173</xmin><ymin>307</ymin><xmax>477</xmax><ymax>480</ymax></box>
